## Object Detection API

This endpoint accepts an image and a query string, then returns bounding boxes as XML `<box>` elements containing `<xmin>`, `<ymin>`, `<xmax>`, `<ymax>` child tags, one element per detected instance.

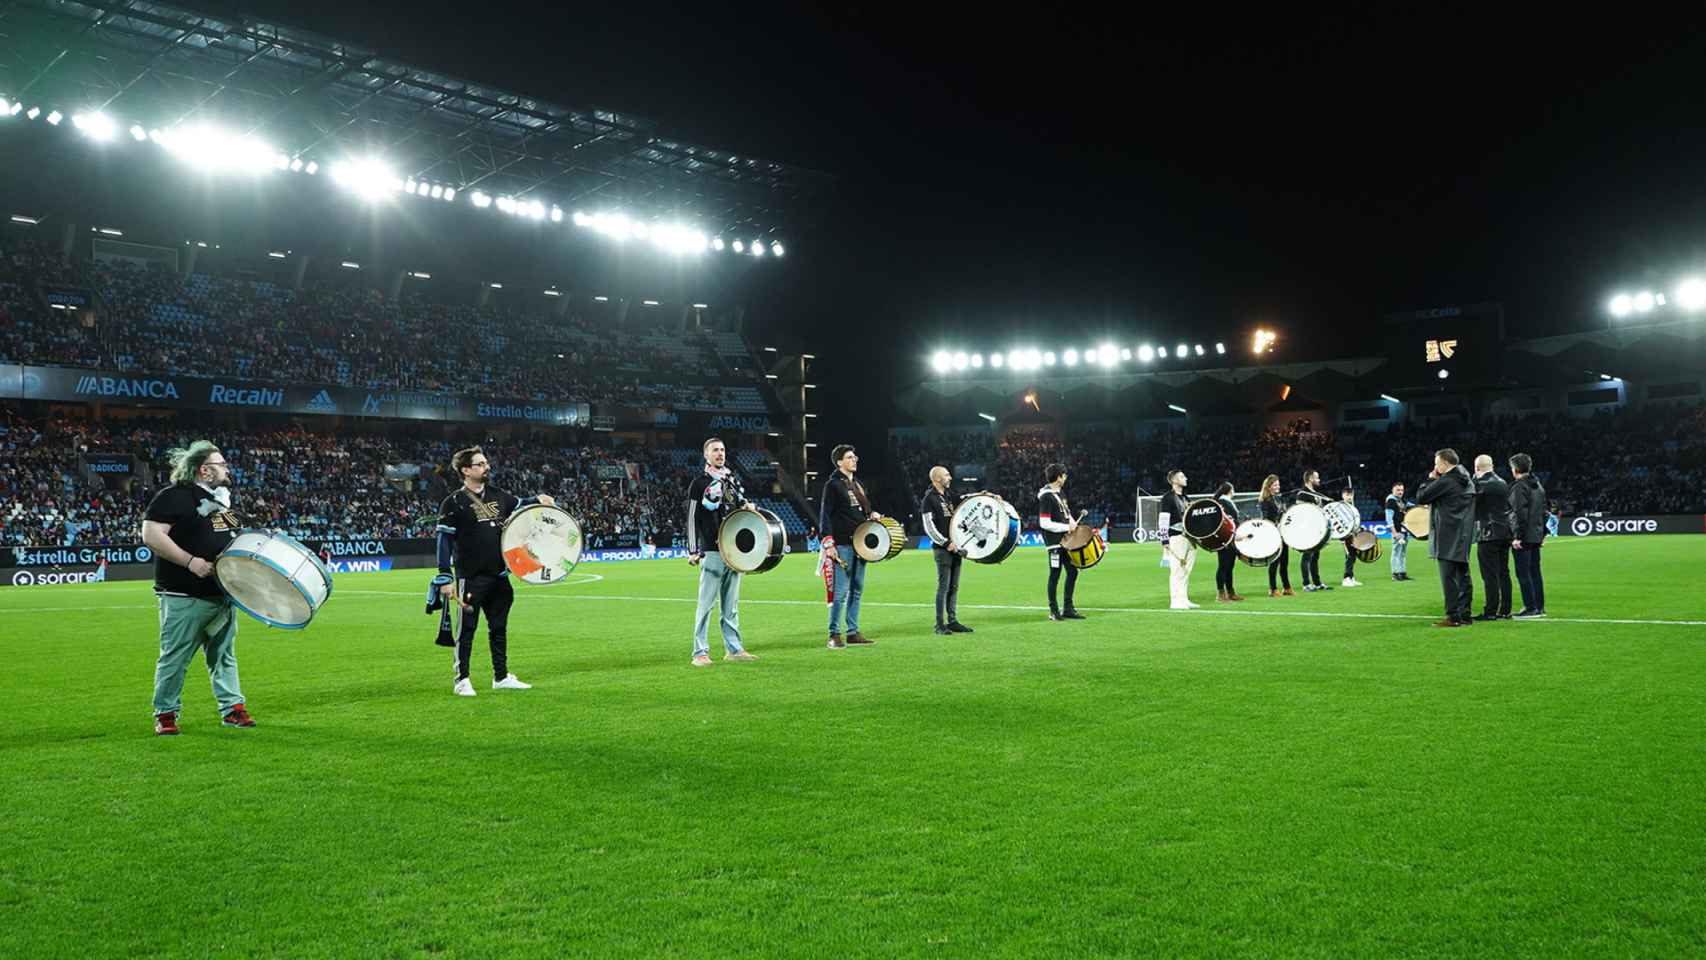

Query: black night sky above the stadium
<box><xmin>223</xmin><ymin>2</ymin><xmax>1706</xmax><ymax>453</ymax></box>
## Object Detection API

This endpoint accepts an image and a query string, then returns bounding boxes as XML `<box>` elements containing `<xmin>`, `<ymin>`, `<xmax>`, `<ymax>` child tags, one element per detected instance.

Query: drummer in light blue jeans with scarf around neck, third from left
<box><xmin>688</xmin><ymin>437</ymin><xmax>757</xmax><ymax>667</ymax></box>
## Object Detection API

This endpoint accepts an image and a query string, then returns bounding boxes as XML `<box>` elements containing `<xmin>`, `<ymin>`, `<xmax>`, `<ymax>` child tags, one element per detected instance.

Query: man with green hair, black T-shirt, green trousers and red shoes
<box><xmin>142</xmin><ymin>440</ymin><xmax>254</xmax><ymax>737</ymax></box>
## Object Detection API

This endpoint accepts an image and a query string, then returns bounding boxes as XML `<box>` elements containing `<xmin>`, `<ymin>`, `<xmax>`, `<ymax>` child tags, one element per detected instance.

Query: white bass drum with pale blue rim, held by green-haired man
<box><xmin>213</xmin><ymin>530</ymin><xmax>331</xmax><ymax>629</ymax></box>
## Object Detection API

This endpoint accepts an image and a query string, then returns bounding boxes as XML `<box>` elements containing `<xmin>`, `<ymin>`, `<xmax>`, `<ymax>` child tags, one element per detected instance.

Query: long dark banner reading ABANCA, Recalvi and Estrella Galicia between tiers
<box><xmin>0</xmin><ymin>365</ymin><xmax>592</xmax><ymax>426</ymax></box>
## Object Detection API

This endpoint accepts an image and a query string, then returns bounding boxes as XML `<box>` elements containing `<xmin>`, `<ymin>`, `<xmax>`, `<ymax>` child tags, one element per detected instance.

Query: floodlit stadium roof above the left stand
<box><xmin>0</xmin><ymin>0</ymin><xmax>831</xmax><ymax>235</ymax></box>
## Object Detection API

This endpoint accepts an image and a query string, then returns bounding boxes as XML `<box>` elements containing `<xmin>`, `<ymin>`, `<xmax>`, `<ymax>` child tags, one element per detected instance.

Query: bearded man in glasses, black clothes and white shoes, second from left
<box><xmin>438</xmin><ymin>447</ymin><xmax>556</xmax><ymax>697</ymax></box>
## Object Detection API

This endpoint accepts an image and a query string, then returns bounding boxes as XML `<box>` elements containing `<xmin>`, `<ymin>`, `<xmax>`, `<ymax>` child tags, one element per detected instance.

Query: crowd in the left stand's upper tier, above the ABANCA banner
<box><xmin>0</xmin><ymin>244</ymin><xmax>763</xmax><ymax>411</ymax></box>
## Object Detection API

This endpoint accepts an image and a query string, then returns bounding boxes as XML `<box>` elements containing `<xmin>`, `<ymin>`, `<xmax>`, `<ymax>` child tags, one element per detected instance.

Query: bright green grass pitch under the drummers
<box><xmin>0</xmin><ymin>535</ymin><xmax>1706</xmax><ymax>958</ymax></box>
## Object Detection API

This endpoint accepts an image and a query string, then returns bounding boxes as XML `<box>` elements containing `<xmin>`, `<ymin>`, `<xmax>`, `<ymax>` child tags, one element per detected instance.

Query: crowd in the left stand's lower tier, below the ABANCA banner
<box><xmin>0</xmin><ymin>417</ymin><xmax>747</xmax><ymax>546</ymax></box>
